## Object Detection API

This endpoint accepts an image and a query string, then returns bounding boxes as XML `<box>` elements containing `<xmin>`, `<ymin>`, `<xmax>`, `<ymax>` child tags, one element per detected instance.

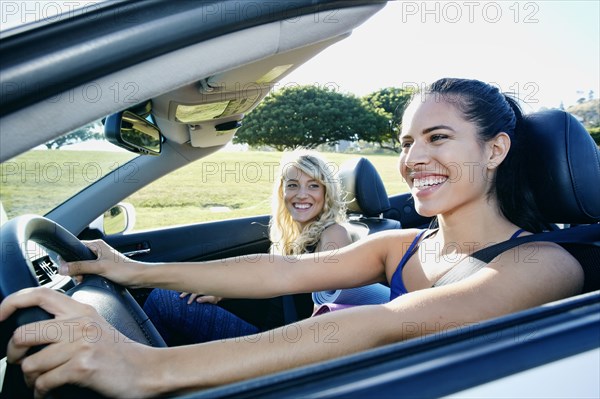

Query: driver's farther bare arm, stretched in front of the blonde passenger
<box><xmin>61</xmin><ymin>231</ymin><xmax>405</xmax><ymax>298</ymax></box>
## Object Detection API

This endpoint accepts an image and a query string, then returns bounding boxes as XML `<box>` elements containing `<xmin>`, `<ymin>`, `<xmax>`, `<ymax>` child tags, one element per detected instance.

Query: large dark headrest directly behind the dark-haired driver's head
<box><xmin>523</xmin><ymin>110</ymin><xmax>600</xmax><ymax>224</ymax></box>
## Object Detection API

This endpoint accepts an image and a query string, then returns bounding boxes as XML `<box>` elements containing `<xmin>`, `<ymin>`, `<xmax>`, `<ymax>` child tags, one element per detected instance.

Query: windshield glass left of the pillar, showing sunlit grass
<box><xmin>0</xmin><ymin>121</ymin><xmax>136</xmax><ymax>219</ymax></box>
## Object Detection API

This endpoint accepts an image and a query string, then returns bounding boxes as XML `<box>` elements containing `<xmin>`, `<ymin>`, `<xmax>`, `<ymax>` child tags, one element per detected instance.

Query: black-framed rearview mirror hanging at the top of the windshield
<box><xmin>104</xmin><ymin>111</ymin><xmax>162</xmax><ymax>155</ymax></box>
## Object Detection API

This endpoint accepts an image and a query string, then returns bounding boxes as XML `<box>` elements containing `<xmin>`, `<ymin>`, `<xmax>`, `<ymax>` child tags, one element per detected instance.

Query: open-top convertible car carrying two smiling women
<box><xmin>0</xmin><ymin>0</ymin><xmax>600</xmax><ymax>399</ymax></box>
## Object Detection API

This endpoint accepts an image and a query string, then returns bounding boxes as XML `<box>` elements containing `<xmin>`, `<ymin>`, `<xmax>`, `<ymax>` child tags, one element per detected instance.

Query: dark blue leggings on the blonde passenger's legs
<box><xmin>144</xmin><ymin>289</ymin><xmax>260</xmax><ymax>346</ymax></box>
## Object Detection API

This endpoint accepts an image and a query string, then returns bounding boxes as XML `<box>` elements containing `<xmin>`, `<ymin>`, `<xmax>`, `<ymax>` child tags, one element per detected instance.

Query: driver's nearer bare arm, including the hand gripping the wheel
<box><xmin>0</xmin><ymin>243</ymin><xmax>583</xmax><ymax>397</ymax></box>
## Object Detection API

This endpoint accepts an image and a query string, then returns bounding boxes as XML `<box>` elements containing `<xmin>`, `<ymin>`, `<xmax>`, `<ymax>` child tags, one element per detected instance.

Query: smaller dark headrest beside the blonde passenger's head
<box><xmin>338</xmin><ymin>157</ymin><xmax>390</xmax><ymax>217</ymax></box>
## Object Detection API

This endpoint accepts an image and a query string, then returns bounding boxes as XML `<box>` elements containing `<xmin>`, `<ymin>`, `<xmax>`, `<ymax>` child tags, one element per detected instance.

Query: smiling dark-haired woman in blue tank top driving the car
<box><xmin>0</xmin><ymin>79</ymin><xmax>583</xmax><ymax>397</ymax></box>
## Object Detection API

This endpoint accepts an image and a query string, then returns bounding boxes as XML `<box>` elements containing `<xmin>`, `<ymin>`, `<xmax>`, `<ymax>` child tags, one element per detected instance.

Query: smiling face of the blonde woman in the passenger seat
<box><xmin>283</xmin><ymin>166</ymin><xmax>325</xmax><ymax>228</ymax></box>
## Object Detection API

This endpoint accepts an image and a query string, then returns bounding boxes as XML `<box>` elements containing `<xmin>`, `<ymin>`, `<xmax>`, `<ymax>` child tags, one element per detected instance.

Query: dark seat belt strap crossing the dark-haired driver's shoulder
<box><xmin>432</xmin><ymin>224</ymin><xmax>600</xmax><ymax>292</ymax></box>
